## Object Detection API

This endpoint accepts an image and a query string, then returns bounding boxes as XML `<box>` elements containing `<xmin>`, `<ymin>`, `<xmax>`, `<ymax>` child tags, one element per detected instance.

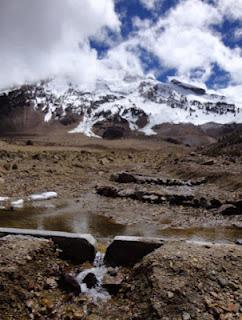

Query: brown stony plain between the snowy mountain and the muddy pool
<box><xmin>0</xmin><ymin>130</ymin><xmax>242</xmax><ymax>228</ymax></box>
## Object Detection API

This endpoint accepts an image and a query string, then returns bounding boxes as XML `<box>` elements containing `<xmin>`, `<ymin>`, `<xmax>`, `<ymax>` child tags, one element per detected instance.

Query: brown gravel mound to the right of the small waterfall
<box><xmin>98</xmin><ymin>242</ymin><xmax>242</xmax><ymax>320</ymax></box>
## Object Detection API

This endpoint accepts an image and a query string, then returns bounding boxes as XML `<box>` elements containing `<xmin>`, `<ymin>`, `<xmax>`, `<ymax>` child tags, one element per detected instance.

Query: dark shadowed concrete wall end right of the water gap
<box><xmin>104</xmin><ymin>236</ymin><xmax>164</xmax><ymax>267</ymax></box>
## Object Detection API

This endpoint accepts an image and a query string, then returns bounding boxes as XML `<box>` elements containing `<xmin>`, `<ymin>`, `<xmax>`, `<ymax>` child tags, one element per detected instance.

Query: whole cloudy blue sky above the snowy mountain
<box><xmin>0</xmin><ymin>0</ymin><xmax>242</xmax><ymax>100</ymax></box>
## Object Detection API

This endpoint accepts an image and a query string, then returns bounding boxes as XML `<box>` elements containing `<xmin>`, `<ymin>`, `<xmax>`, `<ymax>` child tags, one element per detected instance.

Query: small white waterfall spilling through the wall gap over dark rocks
<box><xmin>76</xmin><ymin>252</ymin><xmax>110</xmax><ymax>302</ymax></box>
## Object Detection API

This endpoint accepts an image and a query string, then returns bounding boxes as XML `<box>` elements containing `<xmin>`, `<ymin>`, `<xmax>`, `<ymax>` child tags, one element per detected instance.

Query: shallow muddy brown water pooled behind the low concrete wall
<box><xmin>0</xmin><ymin>200</ymin><xmax>242</xmax><ymax>242</ymax></box>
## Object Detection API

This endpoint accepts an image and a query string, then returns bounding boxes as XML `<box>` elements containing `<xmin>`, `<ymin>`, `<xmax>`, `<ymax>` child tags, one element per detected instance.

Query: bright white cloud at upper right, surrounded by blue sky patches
<box><xmin>123</xmin><ymin>0</ymin><xmax>242</xmax><ymax>83</ymax></box>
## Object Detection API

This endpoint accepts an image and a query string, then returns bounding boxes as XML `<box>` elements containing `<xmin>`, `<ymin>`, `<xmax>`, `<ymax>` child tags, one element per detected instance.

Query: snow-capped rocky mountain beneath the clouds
<box><xmin>0</xmin><ymin>76</ymin><xmax>242</xmax><ymax>136</ymax></box>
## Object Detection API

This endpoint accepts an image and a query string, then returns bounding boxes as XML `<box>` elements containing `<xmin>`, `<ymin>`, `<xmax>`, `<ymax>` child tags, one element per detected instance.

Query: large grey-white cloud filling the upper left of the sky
<box><xmin>0</xmin><ymin>0</ymin><xmax>120</xmax><ymax>88</ymax></box>
